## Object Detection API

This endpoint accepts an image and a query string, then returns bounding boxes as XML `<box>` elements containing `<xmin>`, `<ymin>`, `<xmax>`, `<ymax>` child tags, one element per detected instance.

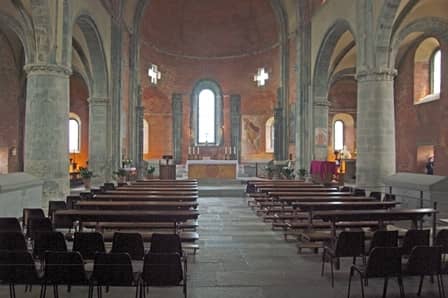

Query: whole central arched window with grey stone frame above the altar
<box><xmin>190</xmin><ymin>80</ymin><xmax>223</xmax><ymax>146</ymax></box>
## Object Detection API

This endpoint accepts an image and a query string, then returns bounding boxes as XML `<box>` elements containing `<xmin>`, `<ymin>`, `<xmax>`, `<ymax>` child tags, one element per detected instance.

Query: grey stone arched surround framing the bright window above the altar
<box><xmin>190</xmin><ymin>79</ymin><xmax>224</xmax><ymax>146</ymax></box>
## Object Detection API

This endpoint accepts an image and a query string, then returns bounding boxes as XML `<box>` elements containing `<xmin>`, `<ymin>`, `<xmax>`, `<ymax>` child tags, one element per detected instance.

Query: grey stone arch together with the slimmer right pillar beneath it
<box><xmin>311</xmin><ymin>19</ymin><xmax>356</xmax><ymax>159</ymax></box>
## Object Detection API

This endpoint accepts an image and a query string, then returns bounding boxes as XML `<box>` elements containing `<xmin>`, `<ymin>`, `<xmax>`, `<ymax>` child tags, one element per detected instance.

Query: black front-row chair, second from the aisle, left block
<box><xmin>89</xmin><ymin>253</ymin><xmax>140</xmax><ymax>298</ymax></box>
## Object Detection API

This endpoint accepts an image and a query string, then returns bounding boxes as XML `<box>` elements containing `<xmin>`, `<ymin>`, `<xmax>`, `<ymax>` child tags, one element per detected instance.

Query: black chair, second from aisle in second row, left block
<box><xmin>110</xmin><ymin>232</ymin><xmax>145</xmax><ymax>260</ymax></box>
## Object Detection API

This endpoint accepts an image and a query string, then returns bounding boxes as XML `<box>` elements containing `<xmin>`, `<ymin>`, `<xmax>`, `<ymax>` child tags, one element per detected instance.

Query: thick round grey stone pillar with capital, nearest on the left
<box><xmin>24</xmin><ymin>64</ymin><xmax>71</xmax><ymax>208</ymax></box>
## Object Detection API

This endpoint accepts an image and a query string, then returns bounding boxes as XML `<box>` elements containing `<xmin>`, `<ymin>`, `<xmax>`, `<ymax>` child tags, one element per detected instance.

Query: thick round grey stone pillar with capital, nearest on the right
<box><xmin>356</xmin><ymin>70</ymin><xmax>395</xmax><ymax>189</ymax></box>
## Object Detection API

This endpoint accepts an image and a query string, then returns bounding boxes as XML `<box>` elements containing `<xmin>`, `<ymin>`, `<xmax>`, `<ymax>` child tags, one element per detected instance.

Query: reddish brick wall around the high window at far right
<box><xmin>395</xmin><ymin>44</ymin><xmax>448</xmax><ymax>175</ymax></box>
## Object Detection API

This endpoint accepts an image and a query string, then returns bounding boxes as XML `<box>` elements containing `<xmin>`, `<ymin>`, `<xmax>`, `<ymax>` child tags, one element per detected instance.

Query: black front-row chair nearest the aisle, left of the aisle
<box><xmin>140</xmin><ymin>252</ymin><xmax>187</xmax><ymax>298</ymax></box>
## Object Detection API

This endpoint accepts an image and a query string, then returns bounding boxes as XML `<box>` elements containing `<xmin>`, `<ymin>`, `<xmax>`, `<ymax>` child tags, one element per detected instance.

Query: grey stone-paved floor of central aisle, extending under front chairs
<box><xmin>0</xmin><ymin>185</ymin><xmax>437</xmax><ymax>298</ymax></box>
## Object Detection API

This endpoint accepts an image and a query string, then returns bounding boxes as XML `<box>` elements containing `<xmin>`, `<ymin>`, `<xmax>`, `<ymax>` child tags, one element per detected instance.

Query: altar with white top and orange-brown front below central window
<box><xmin>186</xmin><ymin>159</ymin><xmax>238</xmax><ymax>179</ymax></box>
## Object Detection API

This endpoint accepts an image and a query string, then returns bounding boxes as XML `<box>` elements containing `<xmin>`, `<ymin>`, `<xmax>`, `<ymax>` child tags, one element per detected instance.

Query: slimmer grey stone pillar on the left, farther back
<box><xmin>88</xmin><ymin>97</ymin><xmax>110</xmax><ymax>184</ymax></box>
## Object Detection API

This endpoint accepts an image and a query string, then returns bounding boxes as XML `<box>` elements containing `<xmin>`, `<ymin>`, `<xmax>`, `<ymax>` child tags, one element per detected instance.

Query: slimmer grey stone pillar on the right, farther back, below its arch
<box><xmin>313</xmin><ymin>97</ymin><xmax>330</xmax><ymax>160</ymax></box>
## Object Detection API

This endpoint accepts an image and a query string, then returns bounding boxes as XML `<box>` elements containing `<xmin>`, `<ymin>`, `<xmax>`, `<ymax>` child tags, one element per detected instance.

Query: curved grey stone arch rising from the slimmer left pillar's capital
<box><xmin>74</xmin><ymin>13</ymin><xmax>109</xmax><ymax>98</ymax></box>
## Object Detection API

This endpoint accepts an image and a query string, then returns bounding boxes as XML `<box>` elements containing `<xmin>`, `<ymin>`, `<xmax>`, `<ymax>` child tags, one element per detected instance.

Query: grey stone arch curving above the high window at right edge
<box><xmin>390</xmin><ymin>17</ymin><xmax>448</xmax><ymax>65</ymax></box>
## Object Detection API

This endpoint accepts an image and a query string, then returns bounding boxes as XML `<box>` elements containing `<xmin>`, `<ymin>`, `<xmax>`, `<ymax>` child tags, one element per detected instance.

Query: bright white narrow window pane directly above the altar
<box><xmin>198</xmin><ymin>89</ymin><xmax>216</xmax><ymax>144</ymax></box>
